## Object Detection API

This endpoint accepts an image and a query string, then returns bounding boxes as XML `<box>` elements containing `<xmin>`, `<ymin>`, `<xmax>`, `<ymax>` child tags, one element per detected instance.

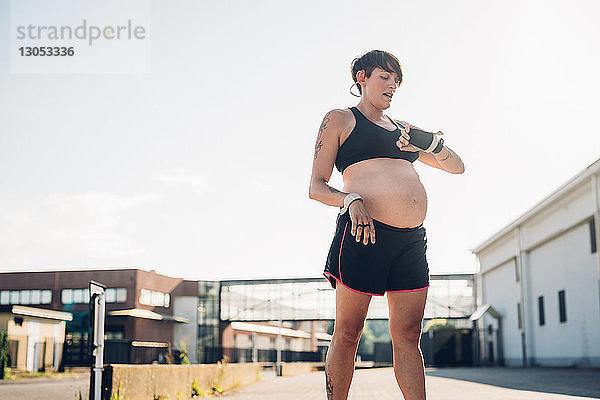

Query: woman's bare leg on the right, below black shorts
<box><xmin>387</xmin><ymin>289</ymin><xmax>427</xmax><ymax>400</ymax></box>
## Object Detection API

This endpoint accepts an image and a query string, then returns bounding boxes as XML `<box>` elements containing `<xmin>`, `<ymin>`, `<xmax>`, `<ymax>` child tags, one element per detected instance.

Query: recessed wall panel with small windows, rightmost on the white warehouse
<box><xmin>528</xmin><ymin>224</ymin><xmax>600</xmax><ymax>366</ymax></box>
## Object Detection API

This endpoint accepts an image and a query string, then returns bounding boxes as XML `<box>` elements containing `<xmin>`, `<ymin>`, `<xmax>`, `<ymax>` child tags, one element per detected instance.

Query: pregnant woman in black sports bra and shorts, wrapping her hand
<box><xmin>309</xmin><ymin>50</ymin><xmax>464</xmax><ymax>400</ymax></box>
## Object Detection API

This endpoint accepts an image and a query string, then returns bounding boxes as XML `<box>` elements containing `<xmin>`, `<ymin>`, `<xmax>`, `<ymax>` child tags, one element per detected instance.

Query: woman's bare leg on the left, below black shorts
<box><xmin>325</xmin><ymin>283</ymin><xmax>371</xmax><ymax>400</ymax></box>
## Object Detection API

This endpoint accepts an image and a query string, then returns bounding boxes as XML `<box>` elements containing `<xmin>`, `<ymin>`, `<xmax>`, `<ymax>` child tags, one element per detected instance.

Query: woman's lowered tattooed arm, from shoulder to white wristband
<box><xmin>308</xmin><ymin>110</ymin><xmax>348</xmax><ymax>207</ymax></box>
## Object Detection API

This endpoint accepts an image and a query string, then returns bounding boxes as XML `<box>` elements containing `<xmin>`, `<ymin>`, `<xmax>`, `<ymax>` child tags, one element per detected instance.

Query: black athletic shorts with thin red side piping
<box><xmin>323</xmin><ymin>212</ymin><xmax>429</xmax><ymax>296</ymax></box>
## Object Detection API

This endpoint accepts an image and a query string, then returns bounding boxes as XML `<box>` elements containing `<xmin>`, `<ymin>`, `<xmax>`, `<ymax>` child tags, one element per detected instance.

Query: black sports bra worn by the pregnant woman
<box><xmin>335</xmin><ymin>107</ymin><xmax>419</xmax><ymax>174</ymax></box>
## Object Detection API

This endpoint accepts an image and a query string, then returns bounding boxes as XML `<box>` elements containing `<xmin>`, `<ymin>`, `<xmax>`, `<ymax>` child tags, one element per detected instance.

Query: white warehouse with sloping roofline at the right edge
<box><xmin>472</xmin><ymin>160</ymin><xmax>600</xmax><ymax>367</ymax></box>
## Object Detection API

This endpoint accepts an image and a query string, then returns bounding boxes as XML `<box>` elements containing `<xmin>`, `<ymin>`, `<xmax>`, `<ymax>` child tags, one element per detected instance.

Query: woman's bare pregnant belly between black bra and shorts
<box><xmin>342</xmin><ymin>158</ymin><xmax>427</xmax><ymax>228</ymax></box>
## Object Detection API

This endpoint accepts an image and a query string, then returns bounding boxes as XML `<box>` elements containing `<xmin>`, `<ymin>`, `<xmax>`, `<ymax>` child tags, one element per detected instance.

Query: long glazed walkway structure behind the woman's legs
<box><xmin>218</xmin><ymin>274</ymin><xmax>477</xmax><ymax>366</ymax></box>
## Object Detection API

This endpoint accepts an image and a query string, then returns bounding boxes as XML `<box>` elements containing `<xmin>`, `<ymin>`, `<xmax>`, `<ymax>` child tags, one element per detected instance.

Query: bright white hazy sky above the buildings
<box><xmin>0</xmin><ymin>0</ymin><xmax>600</xmax><ymax>279</ymax></box>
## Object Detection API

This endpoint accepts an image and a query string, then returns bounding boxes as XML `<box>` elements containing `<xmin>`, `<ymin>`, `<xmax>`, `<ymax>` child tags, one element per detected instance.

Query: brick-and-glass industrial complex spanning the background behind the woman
<box><xmin>0</xmin><ymin>269</ymin><xmax>477</xmax><ymax>366</ymax></box>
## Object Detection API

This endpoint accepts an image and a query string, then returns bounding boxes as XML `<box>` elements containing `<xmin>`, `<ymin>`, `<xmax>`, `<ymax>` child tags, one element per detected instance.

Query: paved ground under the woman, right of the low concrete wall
<box><xmin>225</xmin><ymin>368</ymin><xmax>600</xmax><ymax>400</ymax></box>
